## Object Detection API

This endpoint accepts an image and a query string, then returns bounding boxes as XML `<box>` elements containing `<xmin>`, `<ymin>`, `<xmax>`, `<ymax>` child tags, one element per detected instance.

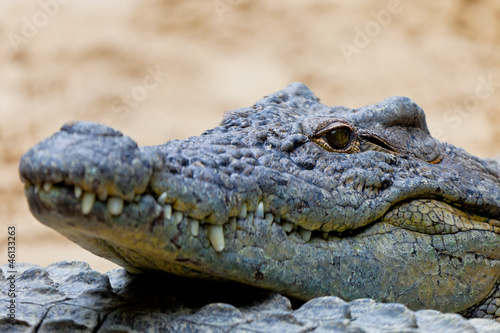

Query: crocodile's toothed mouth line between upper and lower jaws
<box><xmin>25</xmin><ymin>180</ymin><xmax>500</xmax><ymax>252</ymax></box>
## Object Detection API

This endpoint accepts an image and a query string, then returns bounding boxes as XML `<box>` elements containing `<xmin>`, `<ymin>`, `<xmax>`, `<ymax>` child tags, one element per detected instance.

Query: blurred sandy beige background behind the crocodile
<box><xmin>0</xmin><ymin>0</ymin><xmax>500</xmax><ymax>271</ymax></box>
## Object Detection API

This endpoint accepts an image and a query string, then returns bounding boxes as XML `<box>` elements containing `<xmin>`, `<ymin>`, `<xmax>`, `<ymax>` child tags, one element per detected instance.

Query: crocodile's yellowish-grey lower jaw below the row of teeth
<box><xmin>25</xmin><ymin>175</ymin><xmax>500</xmax><ymax>311</ymax></box>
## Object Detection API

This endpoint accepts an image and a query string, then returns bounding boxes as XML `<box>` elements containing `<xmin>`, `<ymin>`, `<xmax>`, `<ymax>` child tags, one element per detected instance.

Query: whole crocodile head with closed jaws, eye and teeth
<box><xmin>20</xmin><ymin>83</ymin><xmax>500</xmax><ymax>311</ymax></box>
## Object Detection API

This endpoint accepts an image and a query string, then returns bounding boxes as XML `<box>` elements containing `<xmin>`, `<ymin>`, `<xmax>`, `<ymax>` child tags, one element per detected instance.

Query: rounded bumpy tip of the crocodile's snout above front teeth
<box><xmin>19</xmin><ymin>122</ymin><xmax>153</xmax><ymax>202</ymax></box>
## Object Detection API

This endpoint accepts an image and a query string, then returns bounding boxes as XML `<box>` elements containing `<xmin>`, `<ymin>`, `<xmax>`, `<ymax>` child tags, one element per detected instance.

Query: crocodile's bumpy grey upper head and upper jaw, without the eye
<box><xmin>20</xmin><ymin>83</ymin><xmax>500</xmax><ymax>231</ymax></box>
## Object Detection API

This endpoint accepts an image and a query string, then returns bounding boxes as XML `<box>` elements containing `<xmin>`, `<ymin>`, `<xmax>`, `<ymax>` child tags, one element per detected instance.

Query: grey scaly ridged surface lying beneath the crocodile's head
<box><xmin>0</xmin><ymin>261</ymin><xmax>500</xmax><ymax>333</ymax></box>
